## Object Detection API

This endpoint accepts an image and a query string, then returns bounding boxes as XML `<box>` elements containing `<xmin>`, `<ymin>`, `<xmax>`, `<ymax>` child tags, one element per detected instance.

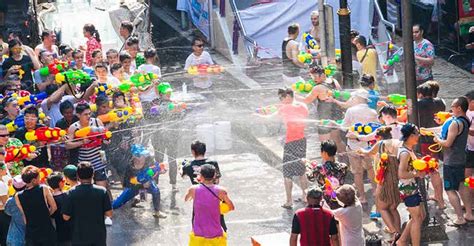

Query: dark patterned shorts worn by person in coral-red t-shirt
<box><xmin>283</xmin><ymin>138</ymin><xmax>306</xmax><ymax>178</ymax></box>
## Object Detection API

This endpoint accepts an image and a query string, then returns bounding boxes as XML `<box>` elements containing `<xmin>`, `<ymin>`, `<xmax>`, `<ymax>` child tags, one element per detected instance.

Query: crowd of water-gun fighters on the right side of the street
<box><xmin>276</xmin><ymin>12</ymin><xmax>474</xmax><ymax>245</ymax></box>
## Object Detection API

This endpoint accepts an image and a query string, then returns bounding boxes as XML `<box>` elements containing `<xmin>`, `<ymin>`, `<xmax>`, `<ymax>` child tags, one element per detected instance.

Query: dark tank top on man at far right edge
<box><xmin>443</xmin><ymin>116</ymin><xmax>470</xmax><ymax>167</ymax></box>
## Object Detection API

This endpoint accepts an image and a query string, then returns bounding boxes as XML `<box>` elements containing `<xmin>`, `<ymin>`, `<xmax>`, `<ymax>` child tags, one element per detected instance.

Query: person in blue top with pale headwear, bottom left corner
<box><xmin>5</xmin><ymin>175</ymin><xmax>26</xmax><ymax>245</ymax></box>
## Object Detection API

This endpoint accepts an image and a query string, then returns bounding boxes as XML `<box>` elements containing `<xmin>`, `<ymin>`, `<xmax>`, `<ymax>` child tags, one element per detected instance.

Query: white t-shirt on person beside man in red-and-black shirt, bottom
<box><xmin>332</xmin><ymin>201</ymin><xmax>365</xmax><ymax>246</ymax></box>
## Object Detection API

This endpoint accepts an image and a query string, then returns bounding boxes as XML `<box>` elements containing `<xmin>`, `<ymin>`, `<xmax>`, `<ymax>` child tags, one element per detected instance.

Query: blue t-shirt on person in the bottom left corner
<box><xmin>5</xmin><ymin>197</ymin><xmax>26</xmax><ymax>246</ymax></box>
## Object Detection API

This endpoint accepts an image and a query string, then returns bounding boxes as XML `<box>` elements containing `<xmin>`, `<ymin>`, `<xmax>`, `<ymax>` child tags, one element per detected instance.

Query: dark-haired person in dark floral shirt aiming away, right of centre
<box><xmin>313</xmin><ymin>140</ymin><xmax>348</xmax><ymax>208</ymax></box>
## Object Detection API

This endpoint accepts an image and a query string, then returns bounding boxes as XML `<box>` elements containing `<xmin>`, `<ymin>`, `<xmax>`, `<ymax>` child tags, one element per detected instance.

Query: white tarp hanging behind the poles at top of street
<box><xmin>240</xmin><ymin>0</ymin><xmax>371</xmax><ymax>58</ymax></box>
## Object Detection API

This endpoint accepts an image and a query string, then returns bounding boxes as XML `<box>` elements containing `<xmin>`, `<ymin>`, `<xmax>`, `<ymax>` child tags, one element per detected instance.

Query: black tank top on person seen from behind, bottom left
<box><xmin>18</xmin><ymin>186</ymin><xmax>56</xmax><ymax>242</ymax></box>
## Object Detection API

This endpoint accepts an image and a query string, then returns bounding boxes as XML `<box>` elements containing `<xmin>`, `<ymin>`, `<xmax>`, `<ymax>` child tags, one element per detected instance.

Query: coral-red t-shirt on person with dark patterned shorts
<box><xmin>278</xmin><ymin>102</ymin><xmax>308</xmax><ymax>143</ymax></box>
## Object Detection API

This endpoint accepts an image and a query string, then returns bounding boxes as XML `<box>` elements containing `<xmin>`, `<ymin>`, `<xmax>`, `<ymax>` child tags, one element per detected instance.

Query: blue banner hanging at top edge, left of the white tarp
<box><xmin>186</xmin><ymin>0</ymin><xmax>211</xmax><ymax>41</ymax></box>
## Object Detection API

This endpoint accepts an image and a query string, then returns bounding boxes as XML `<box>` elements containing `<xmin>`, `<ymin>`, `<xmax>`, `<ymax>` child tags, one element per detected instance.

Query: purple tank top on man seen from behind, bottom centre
<box><xmin>193</xmin><ymin>184</ymin><xmax>223</xmax><ymax>238</ymax></box>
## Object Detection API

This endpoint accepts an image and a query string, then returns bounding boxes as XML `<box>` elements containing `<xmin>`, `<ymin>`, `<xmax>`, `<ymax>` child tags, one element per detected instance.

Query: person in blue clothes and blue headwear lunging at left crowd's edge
<box><xmin>112</xmin><ymin>144</ymin><xmax>166</xmax><ymax>218</ymax></box>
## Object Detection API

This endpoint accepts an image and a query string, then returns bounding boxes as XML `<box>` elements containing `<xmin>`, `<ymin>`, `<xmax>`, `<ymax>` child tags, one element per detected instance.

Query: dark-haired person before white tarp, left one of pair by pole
<box><xmin>281</xmin><ymin>24</ymin><xmax>304</xmax><ymax>86</ymax></box>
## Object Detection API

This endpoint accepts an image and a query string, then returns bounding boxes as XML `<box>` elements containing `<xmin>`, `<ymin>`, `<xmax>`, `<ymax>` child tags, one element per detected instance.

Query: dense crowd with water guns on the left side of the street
<box><xmin>0</xmin><ymin>18</ymin><xmax>228</xmax><ymax>245</ymax></box>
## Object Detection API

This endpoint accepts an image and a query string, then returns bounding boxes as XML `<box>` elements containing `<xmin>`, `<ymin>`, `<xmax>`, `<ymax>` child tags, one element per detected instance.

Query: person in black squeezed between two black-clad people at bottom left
<box><xmin>47</xmin><ymin>172</ymin><xmax>72</xmax><ymax>245</ymax></box>
